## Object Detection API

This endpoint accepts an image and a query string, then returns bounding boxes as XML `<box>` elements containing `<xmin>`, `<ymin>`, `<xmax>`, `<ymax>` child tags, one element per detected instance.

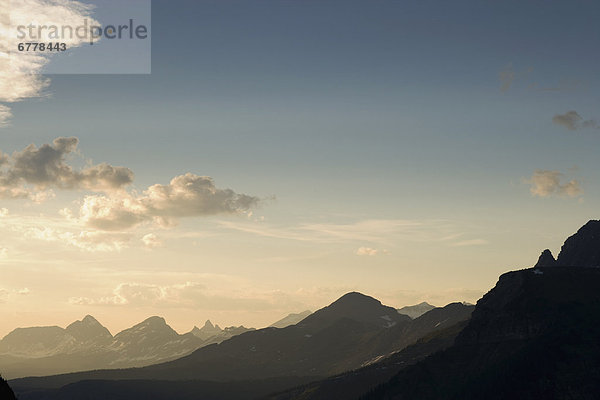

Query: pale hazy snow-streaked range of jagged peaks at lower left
<box><xmin>0</xmin><ymin>315</ymin><xmax>251</xmax><ymax>378</ymax></box>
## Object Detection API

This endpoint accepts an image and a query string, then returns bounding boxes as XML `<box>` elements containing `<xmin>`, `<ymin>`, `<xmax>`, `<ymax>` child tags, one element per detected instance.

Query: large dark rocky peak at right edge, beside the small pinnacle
<box><xmin>556</xmin><ymin>220</ymin><xmax>600</xmax><ymax>267</ymax></box>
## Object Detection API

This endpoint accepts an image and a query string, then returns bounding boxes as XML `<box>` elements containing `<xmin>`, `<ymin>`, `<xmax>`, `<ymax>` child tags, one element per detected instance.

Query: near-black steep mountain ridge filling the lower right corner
<box><xmin>363</xmin><ymin>221</ymin><xmax>600</xmax><ymax>400</ymax></box>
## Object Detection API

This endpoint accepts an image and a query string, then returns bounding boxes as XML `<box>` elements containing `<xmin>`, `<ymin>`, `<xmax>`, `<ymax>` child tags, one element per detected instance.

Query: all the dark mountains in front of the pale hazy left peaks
<box><xmin>5</xmin><ymin>221</ymin><xmax>600</xmax><ymax>400</ymax></box>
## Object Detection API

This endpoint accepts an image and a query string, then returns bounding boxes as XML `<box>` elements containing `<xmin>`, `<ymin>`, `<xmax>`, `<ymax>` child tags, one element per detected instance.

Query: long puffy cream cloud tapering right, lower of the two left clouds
<box><xmin>79</xmin><ymin>173</ymin><xmax>259</xmax><ymax>231</ymax></box>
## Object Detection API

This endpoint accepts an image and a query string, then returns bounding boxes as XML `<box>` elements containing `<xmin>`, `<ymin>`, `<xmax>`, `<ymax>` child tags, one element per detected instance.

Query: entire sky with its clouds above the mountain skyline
<box><xmin>0</xmin><ymin>0</ymin><xmax>600</xmax><ymax>335</ymax></box>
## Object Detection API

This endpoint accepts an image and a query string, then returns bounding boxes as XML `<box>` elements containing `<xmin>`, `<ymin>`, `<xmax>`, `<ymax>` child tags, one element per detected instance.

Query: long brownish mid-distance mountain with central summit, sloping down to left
<box><xmin>13</xmin><ymin>292</ymin><xmax>473</xmax><ymax>399</ymax></box>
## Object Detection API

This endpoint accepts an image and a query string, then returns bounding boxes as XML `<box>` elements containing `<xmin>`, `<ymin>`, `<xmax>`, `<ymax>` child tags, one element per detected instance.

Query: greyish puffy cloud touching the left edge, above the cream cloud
<box><xmin>0</xmin><ymin>137</ymin><xmax>133</xmax><ymax>202</ymax></box>
